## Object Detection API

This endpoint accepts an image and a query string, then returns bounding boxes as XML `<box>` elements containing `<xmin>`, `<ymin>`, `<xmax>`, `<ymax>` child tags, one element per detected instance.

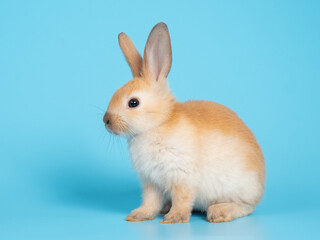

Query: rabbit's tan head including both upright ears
<box><xmin>103</xmin><ymin>23</ymin><xmax>175</xmax><ymax>136</ymax></box>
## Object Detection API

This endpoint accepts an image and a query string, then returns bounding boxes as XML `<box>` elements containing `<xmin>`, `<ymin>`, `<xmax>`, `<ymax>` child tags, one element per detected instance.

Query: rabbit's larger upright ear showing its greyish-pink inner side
<box><xmin>143</xmin><ymin>22</ymin><xmax>172</xmax><ymax>81</ymax></box>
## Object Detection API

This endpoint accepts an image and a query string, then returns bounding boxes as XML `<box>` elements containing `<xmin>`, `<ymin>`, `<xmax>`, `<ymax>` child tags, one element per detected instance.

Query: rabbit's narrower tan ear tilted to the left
<box><xmin>118</xmin><ymin>32</ymin><xmax>142</xmax><ymax>77</ymax></box>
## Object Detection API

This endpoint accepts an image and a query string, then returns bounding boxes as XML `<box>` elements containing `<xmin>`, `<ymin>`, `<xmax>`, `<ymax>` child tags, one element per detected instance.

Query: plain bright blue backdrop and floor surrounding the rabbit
<box><xmin>0</xmin><ymin>0</ymin><xmax>320</xmax><ymax>240</ymax></box>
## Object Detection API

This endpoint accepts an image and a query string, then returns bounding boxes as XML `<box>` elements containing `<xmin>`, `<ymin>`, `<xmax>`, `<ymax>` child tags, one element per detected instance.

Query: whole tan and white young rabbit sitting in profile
<box><xmin>103</xmin><ymin>22</ymin><xmax>265</xmax><ymax>223</ymax></box>
